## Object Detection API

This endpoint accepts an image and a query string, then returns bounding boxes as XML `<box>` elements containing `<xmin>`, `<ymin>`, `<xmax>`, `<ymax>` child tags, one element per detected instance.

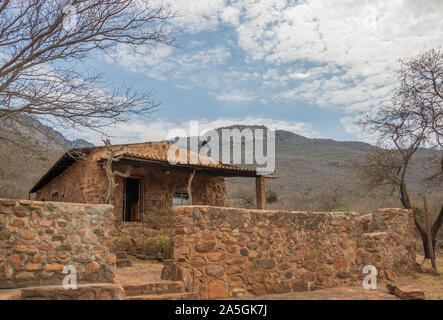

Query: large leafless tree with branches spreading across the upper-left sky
<box><xmin>0</xmin><ymin>0</ymin><xmax>174</xmax><ymax>143</ymax></box>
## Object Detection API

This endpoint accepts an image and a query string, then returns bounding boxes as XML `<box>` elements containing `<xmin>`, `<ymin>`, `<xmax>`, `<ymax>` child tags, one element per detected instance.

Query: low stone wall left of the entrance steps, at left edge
<box><xmin>0</xmin><ymin>199</ymin><xmax>118</xmax><ymax>288</ymax></box>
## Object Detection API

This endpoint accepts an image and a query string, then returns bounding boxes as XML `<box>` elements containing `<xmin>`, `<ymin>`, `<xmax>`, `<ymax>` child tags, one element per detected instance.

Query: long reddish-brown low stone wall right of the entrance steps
<box><xmin>169</xmin><ymin>206</ymin><xmax>415</xmax><ymax>299</ymax></box>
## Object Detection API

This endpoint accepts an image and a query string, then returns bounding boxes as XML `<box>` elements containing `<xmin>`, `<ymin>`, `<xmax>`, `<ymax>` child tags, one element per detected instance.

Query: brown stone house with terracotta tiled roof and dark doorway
<box><xmin>30</xmin><ymin>141</ymin><xmax>266</xmax><ymax>223</ymax></box>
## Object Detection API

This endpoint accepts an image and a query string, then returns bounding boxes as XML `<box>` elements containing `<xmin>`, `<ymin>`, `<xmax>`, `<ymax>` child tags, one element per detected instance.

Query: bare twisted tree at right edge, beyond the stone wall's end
<box><xmin>358</xmin><ymin>50</ymin><xmax>443</xmax><ymax>258</ymax></box>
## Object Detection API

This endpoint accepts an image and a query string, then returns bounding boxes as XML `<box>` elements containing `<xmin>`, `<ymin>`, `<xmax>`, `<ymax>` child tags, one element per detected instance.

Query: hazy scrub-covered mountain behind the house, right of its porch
<box><xmin>221</xmin><ymin>126</ymin><xmax>443</xmax><ymax>212</ymax></box>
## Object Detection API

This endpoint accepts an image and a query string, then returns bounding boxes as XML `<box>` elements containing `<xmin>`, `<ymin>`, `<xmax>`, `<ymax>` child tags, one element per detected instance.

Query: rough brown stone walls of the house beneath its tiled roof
<box><xmin>35</xmin><ymin>143</ymin><xmax>229</xmax><ymax>221</ymax></box>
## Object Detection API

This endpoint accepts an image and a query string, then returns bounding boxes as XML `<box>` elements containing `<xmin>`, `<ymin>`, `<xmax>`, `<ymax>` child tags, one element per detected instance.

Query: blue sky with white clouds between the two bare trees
<box><xmin>73</xmin><ymin>0</ymin><xmax>443</xmax><ymax>143</ymax></box>
